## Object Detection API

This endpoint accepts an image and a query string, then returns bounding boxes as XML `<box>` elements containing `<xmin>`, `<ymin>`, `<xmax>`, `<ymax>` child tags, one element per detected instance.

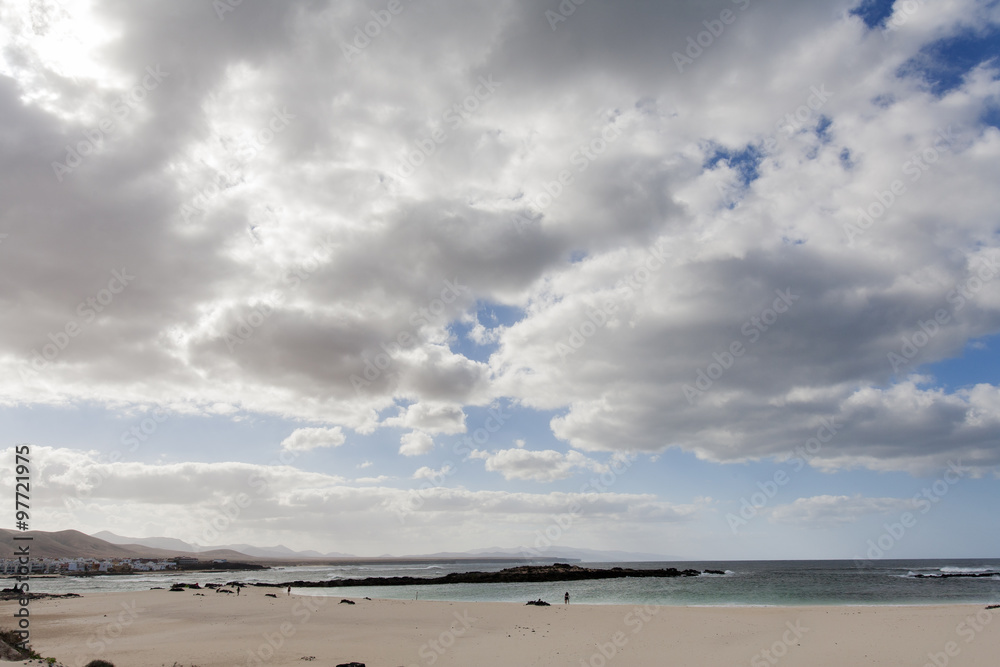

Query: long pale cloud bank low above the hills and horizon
<box><xmin>19</xmin><ymin>446</ymin><xmax>699</xmax><ymax>554</ymax></box>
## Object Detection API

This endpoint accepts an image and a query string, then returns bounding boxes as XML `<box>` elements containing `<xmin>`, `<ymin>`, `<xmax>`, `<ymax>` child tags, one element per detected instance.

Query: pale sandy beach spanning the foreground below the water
<box><xmin>0</xmin><ymin>588</ymin><xmax>1000</xmax><ymax>667</ymax></box>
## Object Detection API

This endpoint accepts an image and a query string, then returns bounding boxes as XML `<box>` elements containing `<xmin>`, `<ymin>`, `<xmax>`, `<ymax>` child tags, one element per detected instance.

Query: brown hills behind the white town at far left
<box><xmin>0</xmin><ymin>529</ymin><xmax>258</xmax><ymax>561</ymax></box>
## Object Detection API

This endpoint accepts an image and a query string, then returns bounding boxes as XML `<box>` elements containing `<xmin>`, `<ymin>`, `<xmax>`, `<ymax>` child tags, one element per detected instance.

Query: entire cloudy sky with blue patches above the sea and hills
<box><xmin>0</xmin><ymin>0</ymin><xmax>1000</xmax><ymax>564</ymax></box>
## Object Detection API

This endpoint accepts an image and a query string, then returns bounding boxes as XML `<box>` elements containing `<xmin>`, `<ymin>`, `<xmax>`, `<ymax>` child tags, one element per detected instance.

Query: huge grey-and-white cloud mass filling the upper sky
<box><xmin>0</xmin><ymin>0</ymin><xmax>1000</xmax><ymax>516</ymax></box>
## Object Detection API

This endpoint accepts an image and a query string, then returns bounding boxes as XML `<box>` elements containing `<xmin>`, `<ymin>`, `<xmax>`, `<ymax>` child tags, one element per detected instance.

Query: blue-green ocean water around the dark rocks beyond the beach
<box><xmin>21</xmin><ymin>559</ymin><xmax>1000</xmax><ymax>606</ymax></box>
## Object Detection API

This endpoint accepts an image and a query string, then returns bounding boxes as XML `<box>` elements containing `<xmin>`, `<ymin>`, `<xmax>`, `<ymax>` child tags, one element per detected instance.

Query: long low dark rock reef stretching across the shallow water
<box><xmin>262</xmin><ymin>563</ymin><xmax>724</xmax><ymax>588</ymax></box>
